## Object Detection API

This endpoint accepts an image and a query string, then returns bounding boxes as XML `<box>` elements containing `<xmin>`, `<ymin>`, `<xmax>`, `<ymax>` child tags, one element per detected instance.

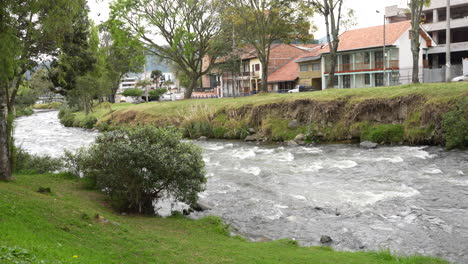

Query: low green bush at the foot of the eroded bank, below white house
<box><xmin>360</xmin><ymin>124</ymin><xmax>405</xmax><ymax>144</ymax></box>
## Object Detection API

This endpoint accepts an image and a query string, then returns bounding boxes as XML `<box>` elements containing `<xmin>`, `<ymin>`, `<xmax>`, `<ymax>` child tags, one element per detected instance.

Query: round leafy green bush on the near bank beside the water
<box><xmin>68</xmin><ymin>127</ymin><xmax>206</xmax><ymax>214</ymax></box>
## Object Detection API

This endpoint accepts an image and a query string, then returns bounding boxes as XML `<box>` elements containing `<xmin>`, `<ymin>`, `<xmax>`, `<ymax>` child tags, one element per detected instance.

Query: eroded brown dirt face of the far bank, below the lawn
<box><xmin>98</xmin><ymin>94</ymin><xmax>468</xmax><ymax>147</ymax></box>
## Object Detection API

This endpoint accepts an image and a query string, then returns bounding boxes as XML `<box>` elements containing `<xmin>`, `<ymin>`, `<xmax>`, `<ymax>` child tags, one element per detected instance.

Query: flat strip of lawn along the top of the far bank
<box><xmin>78</xmin><ymin>82</ymin><xmax>468</xmax><ymax>119</ymax></box>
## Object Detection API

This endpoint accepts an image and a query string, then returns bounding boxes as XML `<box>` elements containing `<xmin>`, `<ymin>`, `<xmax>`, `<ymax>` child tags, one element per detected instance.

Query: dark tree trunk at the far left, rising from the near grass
<box><xmin>0</xmin><ymin>87</ymin><xmax>12</xmax><ymax>181</ymax></box>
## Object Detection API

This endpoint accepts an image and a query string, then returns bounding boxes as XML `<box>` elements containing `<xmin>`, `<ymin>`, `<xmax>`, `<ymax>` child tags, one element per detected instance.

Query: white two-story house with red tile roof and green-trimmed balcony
<box><xmin>321</xmin><ymin>21</ymin><xmax>433</xmax><ymax>89</ymax></box>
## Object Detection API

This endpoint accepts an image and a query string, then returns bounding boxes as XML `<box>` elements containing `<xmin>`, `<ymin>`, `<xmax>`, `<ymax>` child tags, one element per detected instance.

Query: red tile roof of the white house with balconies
<box><xmin>322</xmin><ymin>21</ymin><xmax>411</xmax><ymax>53</ymax></box>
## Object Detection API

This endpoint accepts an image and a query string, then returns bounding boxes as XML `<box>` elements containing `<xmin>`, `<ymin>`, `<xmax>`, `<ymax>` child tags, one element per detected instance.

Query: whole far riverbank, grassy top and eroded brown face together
<box><xmin>64</xmin><ymin>83</ymin><xmax>468</xmax><ymax>148</ymax></box>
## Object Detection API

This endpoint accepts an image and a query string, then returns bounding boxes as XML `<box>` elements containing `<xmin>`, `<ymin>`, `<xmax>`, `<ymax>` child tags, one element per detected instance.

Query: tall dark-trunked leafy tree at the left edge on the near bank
<box><xmin>0</xmin><ymin>0</ymin><xmax>85</xmax><ymax>180</ymax></box>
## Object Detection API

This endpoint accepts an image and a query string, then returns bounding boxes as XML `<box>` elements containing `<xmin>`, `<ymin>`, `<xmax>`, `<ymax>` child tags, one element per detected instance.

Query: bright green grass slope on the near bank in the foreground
<box><xmin>0</xmin><ymin>175</ymin><xmax>447</xmax><ymax>264</ymax></box>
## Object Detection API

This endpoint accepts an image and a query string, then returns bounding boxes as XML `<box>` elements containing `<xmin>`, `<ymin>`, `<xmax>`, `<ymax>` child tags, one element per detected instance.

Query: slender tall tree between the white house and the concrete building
<box><xmin>408</xmin><ymin>0</ymin><xmax>431</xmax><ymax>83</ymax></box>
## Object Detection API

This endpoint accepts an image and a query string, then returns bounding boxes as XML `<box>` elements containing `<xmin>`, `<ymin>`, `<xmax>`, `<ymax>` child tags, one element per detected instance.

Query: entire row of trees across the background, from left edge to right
<box><xmin>0</xmin><ymin>0</ymin><xmax>428</xmax><ymax>180</ymax></box>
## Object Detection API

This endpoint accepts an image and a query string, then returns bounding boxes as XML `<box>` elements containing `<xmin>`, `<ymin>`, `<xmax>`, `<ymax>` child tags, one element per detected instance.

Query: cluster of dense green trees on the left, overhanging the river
<box><xmin>0</xmin><ymin>0</ymin><xmax>144</xmax><ymax>180</ymax></box>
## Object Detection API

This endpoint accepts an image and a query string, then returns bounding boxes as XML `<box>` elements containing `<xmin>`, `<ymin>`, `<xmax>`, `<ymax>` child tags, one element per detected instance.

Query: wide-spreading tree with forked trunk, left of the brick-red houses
<box><xmin>111</xmin><ymin>0</ymin><xmax>226</xmax><ymax>98</ymax></box>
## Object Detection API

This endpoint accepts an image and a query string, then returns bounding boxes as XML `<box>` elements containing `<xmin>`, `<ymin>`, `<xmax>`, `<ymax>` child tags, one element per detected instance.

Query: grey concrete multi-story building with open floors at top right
<box><xmin>386</xmin><ymin>0</ymin><xmax>468</xmax><ymax>82</ymax></box>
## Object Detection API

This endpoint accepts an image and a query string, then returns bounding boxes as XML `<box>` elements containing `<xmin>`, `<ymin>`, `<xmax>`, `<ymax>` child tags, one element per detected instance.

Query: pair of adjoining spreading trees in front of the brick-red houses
<box><xmin>111</xmin><ymin>0</ymin><xmax>313</xmax><ymax>98</ymax></box>
